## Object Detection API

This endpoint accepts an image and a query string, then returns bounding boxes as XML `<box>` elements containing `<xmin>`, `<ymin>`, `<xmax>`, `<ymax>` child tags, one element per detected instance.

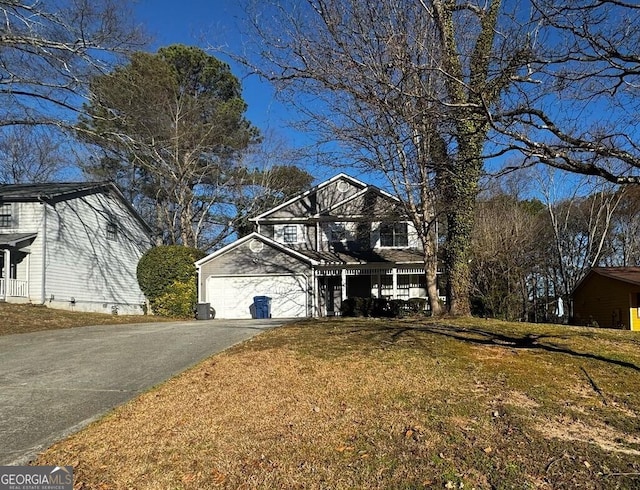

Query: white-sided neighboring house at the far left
<box><xmin>0</xmin><ymin>182</ymin><xmax>151</xmax><ymax>314</ymax></box>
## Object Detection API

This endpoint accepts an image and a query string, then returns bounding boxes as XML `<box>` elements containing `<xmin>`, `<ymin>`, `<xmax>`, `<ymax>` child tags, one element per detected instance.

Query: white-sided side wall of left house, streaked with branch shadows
<box><xmin>42</xmin><ymin>193</ymin><xmax>151</xmax><ymax>314</ymax></box>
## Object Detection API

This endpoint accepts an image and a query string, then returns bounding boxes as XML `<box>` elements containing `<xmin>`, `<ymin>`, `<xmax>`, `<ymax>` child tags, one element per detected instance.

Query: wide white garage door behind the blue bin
<box><xmin>206</xmin><ymin>275</ymin><xmax>307</xmax><ymax>318</ymax></box>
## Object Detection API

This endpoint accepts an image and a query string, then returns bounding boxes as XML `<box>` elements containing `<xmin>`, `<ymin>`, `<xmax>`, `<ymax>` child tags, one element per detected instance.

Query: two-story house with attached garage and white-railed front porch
<box><xmin>196</xmin><ymin>174</ymin><xmax>426</xmax><ymax>318</ymax></box>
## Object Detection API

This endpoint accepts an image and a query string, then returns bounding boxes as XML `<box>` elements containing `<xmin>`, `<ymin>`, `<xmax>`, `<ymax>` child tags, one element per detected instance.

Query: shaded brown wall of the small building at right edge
<box><xmin>573</xmin><ymin>274</ymin><xmax>640</xmax><ymax>329</ymax></box>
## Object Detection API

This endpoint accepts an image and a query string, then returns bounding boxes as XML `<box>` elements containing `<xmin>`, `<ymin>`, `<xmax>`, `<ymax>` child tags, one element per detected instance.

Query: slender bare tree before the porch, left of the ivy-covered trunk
<box><xmin>230</xmin><ymin>0</ymin><xmax>447</xmax><ymax>314</ymax></box>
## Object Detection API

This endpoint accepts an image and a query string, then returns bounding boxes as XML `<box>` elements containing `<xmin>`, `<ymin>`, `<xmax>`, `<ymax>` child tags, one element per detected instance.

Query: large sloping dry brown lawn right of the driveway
<box><xmin>36</xmin><ymin>319</ymin><xmax>640</xmax><ymax>489</ymax></box>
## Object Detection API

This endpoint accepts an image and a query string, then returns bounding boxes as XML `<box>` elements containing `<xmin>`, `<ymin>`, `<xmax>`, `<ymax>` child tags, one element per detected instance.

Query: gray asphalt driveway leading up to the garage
<box><xmin>0</xmin><ymin>320</ymin><xmax>283</xmax><ymax>465</ymax></box>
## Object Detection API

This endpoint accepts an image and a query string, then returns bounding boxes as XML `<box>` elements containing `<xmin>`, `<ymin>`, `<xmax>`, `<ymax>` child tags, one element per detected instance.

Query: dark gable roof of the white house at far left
<box><xmin>0</xmin><ymin>182</ymin><xmax>152</xmax><ymax>233</ymax></box>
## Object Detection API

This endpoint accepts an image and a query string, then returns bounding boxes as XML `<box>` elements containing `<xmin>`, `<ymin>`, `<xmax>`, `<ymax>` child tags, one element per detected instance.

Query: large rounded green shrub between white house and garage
<box><xmin>137</xmin><ymin>245</ymin><xmax>205</xmax><ymax>317</ymax></box>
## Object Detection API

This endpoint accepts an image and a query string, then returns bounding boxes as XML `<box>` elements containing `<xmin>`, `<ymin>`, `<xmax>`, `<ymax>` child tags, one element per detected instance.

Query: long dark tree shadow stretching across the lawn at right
<box><xmin>362</xmin><ymin>324</ymin><xmax>640</xmax><ymax>372</ymax></box>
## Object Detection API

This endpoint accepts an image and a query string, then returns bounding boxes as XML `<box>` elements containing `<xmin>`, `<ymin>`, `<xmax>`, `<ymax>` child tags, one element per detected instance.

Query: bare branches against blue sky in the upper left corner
<box><xmin>0</xmin><ymin>0</ymin><xmax>143</xmax><ymax>132</ymax></box>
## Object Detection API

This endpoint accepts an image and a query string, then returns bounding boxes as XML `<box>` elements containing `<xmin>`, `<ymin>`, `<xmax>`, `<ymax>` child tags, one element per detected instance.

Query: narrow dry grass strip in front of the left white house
<box><xmin>0</xmin><ymin>303</ymin><xmax>169</xmax><ymax>335</ymax></box>
